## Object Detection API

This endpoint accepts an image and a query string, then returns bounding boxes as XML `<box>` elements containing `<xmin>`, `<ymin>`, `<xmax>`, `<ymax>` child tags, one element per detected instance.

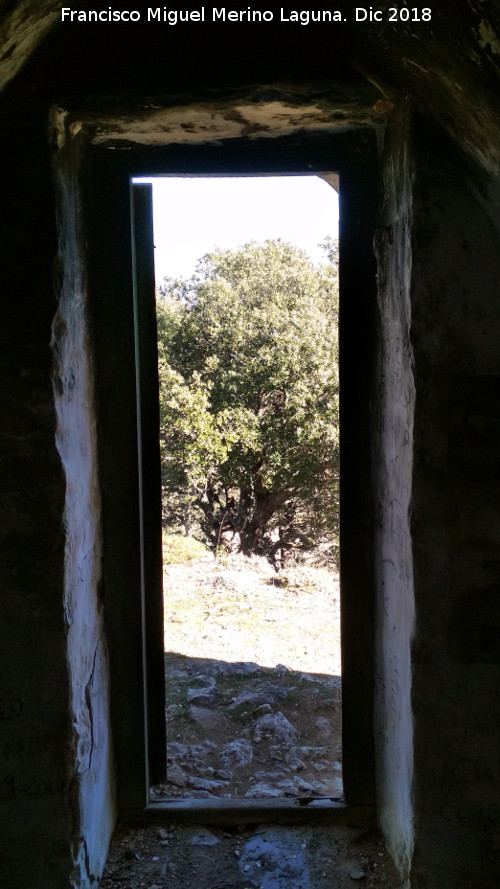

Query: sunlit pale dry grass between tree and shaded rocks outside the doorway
<box><xmin>164</xmin><ymin>555</ymin><xmax>340</xmax><ymax>675</ymax></box>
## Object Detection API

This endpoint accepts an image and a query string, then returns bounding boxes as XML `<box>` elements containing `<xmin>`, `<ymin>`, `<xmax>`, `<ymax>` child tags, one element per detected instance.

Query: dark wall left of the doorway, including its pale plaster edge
<box><xmin>0</xmin><ymin>103</ymin><xmax>114</xmax><ymax>889</ymax></box>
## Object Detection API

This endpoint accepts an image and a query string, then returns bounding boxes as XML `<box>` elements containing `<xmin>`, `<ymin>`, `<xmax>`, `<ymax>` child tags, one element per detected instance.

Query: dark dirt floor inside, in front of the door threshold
<box><xmin>100</xmin><ymin>824</ymin><xmax>401</xmax><ymax>889</ymax></box>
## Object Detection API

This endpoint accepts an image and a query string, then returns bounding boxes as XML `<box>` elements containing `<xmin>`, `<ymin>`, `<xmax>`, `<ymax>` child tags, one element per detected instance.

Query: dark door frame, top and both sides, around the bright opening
<box><xmin>87</xmin><ymin>128</ymin><xmax>376</xmax><ymax>811</ymax></box>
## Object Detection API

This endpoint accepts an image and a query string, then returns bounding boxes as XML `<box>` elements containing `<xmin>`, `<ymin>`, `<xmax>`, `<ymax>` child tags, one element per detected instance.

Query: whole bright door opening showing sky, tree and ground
<box><xmin>135</xmin><ymin>174</ymin><xmax>342</xmax><ymax>801</ymax></box>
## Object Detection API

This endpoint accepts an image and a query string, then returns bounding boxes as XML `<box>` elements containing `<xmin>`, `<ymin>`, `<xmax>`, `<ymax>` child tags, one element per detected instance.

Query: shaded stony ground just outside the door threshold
<box><xmin>159</xmin><ymin>658</ymin><xmax>342</xmax><ymax>799</ymax></box>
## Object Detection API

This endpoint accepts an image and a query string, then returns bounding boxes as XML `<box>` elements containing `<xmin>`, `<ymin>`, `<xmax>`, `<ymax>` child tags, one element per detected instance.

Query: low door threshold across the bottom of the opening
<box><xmin>119</xmin><ymin>797</ymin><xmax>375</xmax><ymax>827</ymax></box>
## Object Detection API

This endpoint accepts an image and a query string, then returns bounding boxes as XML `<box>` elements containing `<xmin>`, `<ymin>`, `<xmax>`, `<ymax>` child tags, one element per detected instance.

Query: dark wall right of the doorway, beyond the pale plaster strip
<box><xmin>411</xmin><ymin>122</ymin><xmax>500</xmax><ymax>889</ymax></box>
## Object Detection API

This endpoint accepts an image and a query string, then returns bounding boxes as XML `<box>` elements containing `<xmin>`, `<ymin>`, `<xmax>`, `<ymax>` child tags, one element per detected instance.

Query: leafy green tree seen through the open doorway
<box><xmin>157</xmin><ymin>239</ymin><xmax>338</xmax><ymax>556</ymax></box>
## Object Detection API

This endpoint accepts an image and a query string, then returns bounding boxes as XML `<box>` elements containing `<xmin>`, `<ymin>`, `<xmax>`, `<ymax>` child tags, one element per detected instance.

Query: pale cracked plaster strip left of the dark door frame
<box><xmin>52</xmin><ymin>131</ymin><xmax>115</xmax><ymax>889</ymax></box>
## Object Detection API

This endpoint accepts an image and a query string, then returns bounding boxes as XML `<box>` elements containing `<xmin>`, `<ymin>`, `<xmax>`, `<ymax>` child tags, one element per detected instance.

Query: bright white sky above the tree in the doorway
<box><xmin>134</xmin><ymin>176</ymin><xmax>339</xmax><ymax>282</ymax></box>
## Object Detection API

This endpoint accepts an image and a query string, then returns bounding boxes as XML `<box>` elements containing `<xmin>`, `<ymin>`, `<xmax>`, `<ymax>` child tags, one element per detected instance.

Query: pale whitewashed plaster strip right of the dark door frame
<box><xmin>372</xmin><ymin>111</ymin><xmax>415</xmax><ymax>880</ymax></box>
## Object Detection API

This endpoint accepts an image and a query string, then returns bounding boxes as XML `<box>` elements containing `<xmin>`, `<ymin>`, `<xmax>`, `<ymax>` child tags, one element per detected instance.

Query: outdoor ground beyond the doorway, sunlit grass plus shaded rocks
<box><xmin>153</xmin><ymin>557</ymin><xmax>342</xmax><ymax>800</ymax></box>
